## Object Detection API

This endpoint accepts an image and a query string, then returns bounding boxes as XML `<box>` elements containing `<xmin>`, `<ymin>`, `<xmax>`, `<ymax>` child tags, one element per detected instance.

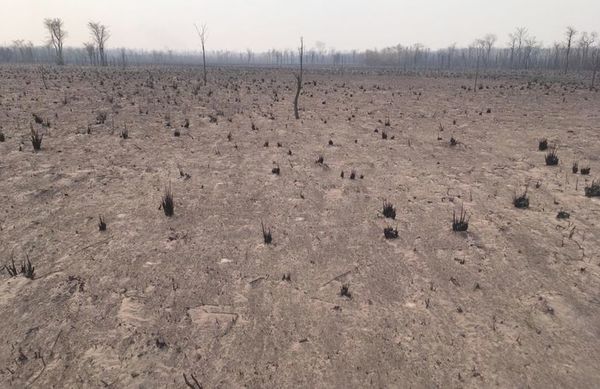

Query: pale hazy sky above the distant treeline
<box><xmin>0</xmin><ymin>0</ymin><xmax>600</xmax><ymax>51</ymax></box>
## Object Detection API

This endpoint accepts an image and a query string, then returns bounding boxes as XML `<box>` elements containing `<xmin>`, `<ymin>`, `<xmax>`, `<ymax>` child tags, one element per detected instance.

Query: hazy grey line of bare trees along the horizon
<box><xmin>0</xmin><ymin>34</ymin><xmax>600</xmax><ymax>72</ymax></box>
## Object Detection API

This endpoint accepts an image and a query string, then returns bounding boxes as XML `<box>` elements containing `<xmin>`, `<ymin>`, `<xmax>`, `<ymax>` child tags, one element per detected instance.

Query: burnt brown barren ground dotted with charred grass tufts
<box><xmin>0</xmin><ymin>66</ymin><xmax>600</xmax><ymax>388</ymax></box>
